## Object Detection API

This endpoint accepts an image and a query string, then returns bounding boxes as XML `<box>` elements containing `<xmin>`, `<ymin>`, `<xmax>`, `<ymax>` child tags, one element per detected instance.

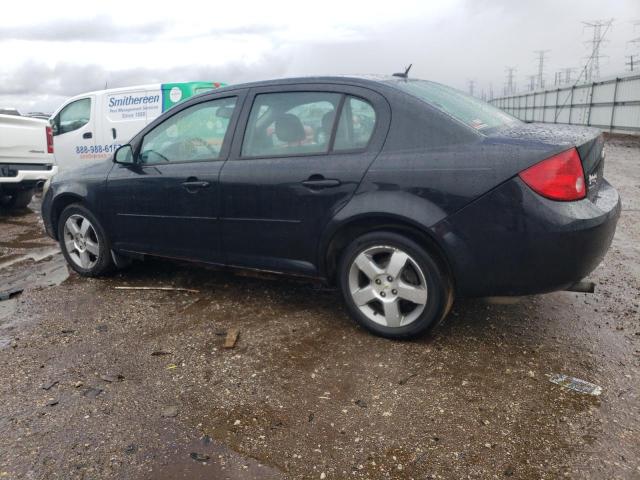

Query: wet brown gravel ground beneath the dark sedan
<box><xmin>0</xmin><ymin>133</ymin><xmax>640</xmax><ymax>480</ymax></box>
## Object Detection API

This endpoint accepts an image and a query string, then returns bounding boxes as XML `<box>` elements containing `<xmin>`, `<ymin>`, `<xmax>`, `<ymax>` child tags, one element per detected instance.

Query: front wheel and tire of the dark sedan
<box><xmin>58</xmin><ymin>203</ymin><xmax>113</xmax><ymax>277</ymax></box>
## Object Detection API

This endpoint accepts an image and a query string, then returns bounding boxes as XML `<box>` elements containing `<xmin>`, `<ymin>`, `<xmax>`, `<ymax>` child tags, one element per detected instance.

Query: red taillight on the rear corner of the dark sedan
<box><xmin>520</xmin><ymin>148</ymin><xmax>587</xmax><ymax>202</ymax></box>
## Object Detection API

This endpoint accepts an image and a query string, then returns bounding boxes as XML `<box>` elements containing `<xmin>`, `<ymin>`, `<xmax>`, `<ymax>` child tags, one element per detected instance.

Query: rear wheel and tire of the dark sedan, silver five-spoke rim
<box><xmin>338</xmin><ymin>231</ymin><xmax>453</xmax><ymax>339</ymax></box>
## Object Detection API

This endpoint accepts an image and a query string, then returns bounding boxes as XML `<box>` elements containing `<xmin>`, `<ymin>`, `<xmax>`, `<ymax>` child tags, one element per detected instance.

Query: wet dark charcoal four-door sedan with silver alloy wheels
<box><xmin>42</xmin><ymin>77</ymin><xmax>620</xmax><ymax>338</ymax></box>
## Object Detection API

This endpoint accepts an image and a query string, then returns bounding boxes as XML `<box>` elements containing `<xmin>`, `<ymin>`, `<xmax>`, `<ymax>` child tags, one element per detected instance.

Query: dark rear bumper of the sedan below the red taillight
<box><xmin>435</xmin><ymin>177</ymin><xmax>621</xmax><ymax>296</ymax></box>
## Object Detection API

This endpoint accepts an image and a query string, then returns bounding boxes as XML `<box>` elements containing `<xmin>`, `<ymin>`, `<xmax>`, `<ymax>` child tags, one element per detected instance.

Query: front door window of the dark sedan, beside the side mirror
<box><xmin>139</xmin><ymin>97</ymin><xmax>236</xmax><ymax>164</ymax></box>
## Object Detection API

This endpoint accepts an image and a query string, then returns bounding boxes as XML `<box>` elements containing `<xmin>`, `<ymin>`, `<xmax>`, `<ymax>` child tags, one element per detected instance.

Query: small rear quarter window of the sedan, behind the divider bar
<box><xmin>333</xmin><ymin>97</ymin><xmax>376</xmax><ymax>151</ymax></box>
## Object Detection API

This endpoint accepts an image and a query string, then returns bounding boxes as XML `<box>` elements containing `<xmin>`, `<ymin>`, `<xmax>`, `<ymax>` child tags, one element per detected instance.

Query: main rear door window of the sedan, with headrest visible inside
<box><xmin>242</xmin><ymin>92</ymin><xmax>342</xmax><ymax>157</ymax></box>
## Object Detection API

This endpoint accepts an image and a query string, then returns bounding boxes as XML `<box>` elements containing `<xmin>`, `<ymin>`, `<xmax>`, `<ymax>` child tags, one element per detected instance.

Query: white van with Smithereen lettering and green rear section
<box><xmin>50</xmin><ymin>82</ymin><xmax>224</xmax><ymax>171</ymax></box>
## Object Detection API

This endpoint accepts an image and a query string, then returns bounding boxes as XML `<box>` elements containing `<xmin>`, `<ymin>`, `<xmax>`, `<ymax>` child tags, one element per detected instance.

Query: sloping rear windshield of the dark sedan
<box><xmin>385</xmin><ymin>80</ymin><xmax>520</xmax><ymax>131</ymax></box>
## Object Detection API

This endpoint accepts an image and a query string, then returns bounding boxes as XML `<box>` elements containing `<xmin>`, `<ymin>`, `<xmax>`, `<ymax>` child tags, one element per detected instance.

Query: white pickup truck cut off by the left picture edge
<box><xmin>0</xmin><ymin>114</ymin><xmax>58</xmax><ymax>208</ymax></box>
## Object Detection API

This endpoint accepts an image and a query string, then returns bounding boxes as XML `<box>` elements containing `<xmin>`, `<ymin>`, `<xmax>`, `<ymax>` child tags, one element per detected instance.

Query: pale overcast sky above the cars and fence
<box><xmin>0</xmin><ymin>0</ymin><xmax>640</xmax><ymax>112</ymax></box>
